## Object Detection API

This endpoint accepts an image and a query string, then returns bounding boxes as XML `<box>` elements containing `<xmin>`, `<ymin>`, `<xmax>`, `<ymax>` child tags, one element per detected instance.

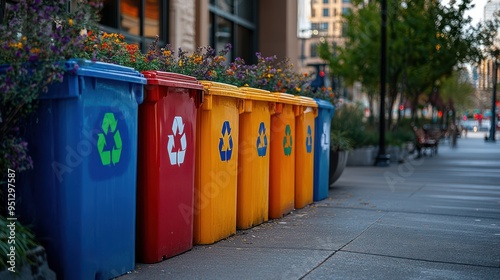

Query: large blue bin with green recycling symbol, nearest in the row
<box><xmin>16</xmin><ymin>60</ymin><xmax>146</xmax><ymax>280</ymax></box>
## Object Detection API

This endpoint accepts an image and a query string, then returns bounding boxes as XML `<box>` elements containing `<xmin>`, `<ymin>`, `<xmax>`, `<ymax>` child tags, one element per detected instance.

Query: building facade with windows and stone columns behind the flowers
<box><xmin>0</xmin><ymin>0</ymin><xmax>298</xmax><ymax>66</ymax></box>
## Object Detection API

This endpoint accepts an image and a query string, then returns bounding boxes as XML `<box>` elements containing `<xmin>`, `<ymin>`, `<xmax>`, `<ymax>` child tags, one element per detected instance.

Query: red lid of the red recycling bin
<box><xmin>142</xmin><ymin>71</ymin><xmax>203</xmax><ymax>90</ymax></box>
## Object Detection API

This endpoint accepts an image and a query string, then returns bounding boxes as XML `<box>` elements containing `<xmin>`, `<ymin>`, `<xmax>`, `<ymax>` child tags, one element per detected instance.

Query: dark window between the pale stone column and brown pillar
<box><xmin>209</xmin><ymin>0</ymin><xmax>258</xmax><ymax>63</ymax></box>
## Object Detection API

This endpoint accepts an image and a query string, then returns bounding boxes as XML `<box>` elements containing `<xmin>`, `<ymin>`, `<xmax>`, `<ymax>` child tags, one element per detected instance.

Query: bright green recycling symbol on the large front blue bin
<box><xmin>97</xmin><ymin>113</ymin><xmax>122</xmax><ymax>165</ymax></box>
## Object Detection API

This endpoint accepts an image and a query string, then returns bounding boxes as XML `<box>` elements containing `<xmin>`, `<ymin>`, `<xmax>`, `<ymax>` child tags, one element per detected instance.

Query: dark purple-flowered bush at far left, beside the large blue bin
<box><xmin>0</xmin><ymin>0</ymin><xmax>102</xmax><ymax>175</ymax></box>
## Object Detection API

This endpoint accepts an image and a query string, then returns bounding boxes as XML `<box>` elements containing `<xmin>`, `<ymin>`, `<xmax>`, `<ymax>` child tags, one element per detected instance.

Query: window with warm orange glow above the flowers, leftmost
<box><xmin>100</xmin><ymin>0</ymin><xmax>168</xmax><ymax>51</ymax></box>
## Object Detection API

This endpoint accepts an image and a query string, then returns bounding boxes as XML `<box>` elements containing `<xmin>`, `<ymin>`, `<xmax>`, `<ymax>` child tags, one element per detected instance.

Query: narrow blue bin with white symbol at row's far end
<box><xmin>313</xmin><ymin>99</ymin><xmax>335</xmax><ymax>201</ymax></box>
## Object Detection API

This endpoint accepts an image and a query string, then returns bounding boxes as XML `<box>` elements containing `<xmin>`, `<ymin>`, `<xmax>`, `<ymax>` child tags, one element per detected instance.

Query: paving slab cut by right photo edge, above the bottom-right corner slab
<box><xmin>343</xmin><ymin>213</ymin><xmax>500</xmax><ymax>268</ymax></box>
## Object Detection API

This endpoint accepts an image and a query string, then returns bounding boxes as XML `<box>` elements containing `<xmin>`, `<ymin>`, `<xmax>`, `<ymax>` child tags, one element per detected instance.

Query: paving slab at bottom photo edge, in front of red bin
<box><xmin>120</xmin><ymin>246</ymin><xmax>333</xmax><ymax>280</ymax></box>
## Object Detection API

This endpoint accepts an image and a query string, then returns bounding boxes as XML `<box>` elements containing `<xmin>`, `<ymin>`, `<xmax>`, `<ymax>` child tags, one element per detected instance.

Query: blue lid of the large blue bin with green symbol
<box><xmin>64</xmin><ymin>59</ymin><xmax>147</xmax><ymax>84</ymax></box>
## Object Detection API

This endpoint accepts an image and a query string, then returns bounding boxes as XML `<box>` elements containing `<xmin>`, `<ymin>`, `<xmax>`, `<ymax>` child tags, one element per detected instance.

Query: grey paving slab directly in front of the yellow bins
<box><xmin>216</xmin><ymin>205</ymin><xmax>384</xmax><ymax>250</ymax></box>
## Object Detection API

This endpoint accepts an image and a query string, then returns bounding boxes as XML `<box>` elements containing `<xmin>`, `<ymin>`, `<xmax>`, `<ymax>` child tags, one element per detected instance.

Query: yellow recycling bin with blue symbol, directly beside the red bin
<box><xmin>193</xmin><ymin>81</ymin><xmax>244</xmax><ymax>244</ymax></box>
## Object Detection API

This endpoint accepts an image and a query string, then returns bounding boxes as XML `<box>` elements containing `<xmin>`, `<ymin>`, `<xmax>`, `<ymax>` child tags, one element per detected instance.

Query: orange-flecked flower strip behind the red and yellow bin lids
<box><xmin>146</xmin><ymin>40</ymin><xmax>314</xmax><ymax>94</ymax></box>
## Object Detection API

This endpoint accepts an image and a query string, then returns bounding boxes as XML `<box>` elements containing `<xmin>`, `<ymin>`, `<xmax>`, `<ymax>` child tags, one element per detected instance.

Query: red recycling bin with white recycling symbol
<box><xmin>136</xmin><ymin>71</ymin><xmax>203</xmax><ymax>263</ymax></box>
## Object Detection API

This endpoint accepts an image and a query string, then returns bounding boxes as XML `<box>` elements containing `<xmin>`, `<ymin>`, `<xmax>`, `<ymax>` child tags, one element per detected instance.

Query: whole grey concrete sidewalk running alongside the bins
<box><xmin>119</xmin><ymin>133</ymin><xmax>500</xmax><ymax>280</ymax></box>
